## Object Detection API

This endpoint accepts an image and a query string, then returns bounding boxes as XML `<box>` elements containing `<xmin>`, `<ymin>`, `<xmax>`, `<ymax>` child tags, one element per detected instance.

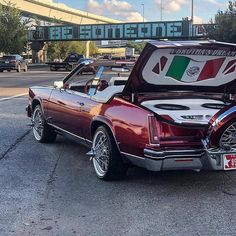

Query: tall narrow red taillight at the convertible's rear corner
<box><xmin>148</xmin><ymin>115</ymin><xmax>159</xmax><ymax>146</ymax></box>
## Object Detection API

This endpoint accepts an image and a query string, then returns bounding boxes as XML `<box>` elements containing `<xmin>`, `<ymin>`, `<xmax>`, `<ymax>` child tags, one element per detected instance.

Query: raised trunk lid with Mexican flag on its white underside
<box><xmin>123</xmin><ymin>41</ymin><xmax>236</xmax><ymax>95</ymax></box>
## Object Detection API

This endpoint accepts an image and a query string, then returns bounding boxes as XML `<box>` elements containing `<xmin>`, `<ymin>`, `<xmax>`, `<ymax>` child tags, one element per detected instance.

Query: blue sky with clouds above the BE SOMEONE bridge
<box><xmin>46</xmin><ymin>0</ymin><xmax>228</xmax><ymax>23</ymax></box>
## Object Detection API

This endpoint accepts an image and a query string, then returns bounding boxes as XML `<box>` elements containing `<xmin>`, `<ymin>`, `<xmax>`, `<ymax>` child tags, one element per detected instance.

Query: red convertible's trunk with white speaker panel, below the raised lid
<box><xmin>137</xmin><ymin>92</ymin><xmax>233</xmax><ymax>149</ymax></box>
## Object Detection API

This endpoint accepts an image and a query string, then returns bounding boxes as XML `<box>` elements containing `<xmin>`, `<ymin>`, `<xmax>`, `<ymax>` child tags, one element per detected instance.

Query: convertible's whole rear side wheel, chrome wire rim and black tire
<box><xmin>92</xmin><ymin>126</ymin><xmax>127</xmax><ymax>180</ymax></box>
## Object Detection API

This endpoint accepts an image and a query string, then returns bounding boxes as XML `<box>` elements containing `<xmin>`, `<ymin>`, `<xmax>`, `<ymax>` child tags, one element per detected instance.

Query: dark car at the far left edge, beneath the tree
<box><xmin>0</xmin><ymin>54</ymin><xmax>28</xmax><ymax>72</ymax></box>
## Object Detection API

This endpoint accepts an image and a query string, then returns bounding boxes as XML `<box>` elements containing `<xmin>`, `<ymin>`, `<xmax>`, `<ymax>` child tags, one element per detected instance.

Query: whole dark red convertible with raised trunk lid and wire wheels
<box><xmin>27</xmin><ymin>41</ymin><xmax>236</xmax><ymax>180</ymax></box>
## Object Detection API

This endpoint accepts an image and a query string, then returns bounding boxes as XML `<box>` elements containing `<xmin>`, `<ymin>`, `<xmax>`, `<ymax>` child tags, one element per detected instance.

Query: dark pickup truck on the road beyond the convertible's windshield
<box><xmin>46</xmin><ymin>53</ymin><xmax>84</xmax><ymax>71</ymax></box>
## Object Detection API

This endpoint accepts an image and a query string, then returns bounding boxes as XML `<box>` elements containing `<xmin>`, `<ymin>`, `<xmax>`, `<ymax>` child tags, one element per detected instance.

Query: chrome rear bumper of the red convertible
<box><xmin>123</xmin><ymin>149</ymin><xmax>236</xmax><ymax>171</ymax></box>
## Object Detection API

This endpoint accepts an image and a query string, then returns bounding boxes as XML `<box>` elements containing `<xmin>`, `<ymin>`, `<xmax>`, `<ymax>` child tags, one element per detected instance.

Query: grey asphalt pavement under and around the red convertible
<box><xmin>0</xmin><ymin>69</ymin><xmax>236</xmax><ymax>236</ymax></box>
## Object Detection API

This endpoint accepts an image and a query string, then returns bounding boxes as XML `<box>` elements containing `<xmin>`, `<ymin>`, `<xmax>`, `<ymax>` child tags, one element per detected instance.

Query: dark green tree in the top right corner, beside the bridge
<box><xmin>209</xmin><ymin>0</ymin><xmax>236</xmax><ymax>43</ymax></box>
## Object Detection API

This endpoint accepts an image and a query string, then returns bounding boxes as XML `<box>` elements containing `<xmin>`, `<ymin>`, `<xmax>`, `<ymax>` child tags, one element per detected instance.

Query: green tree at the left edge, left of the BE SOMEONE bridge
<box><xmin>0</xmin><ymin>2</ymin><xmax>29</xmax><ymax>53</ymax></box>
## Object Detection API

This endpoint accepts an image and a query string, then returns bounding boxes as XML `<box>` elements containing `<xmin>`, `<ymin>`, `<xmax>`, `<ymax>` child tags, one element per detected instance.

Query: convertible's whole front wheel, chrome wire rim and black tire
<box><xmin>32</xmin><ymin>105</ymin><xmax>57</xmax><ymax>143</ymax></box>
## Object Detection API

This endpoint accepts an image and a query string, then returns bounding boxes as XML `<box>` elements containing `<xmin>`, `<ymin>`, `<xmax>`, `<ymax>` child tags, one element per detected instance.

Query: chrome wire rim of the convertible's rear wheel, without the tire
<box><xmin>92</xmin><ymin>130</ymin><xmax>111</xmax><ymax>178</ymax></box>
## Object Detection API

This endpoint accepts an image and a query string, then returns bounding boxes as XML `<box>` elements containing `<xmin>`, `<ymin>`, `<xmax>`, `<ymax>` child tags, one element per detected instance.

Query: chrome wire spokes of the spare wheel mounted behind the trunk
<box><xmin>220</xmin><ymin>122</ymin><xmax>236</xmax><ymax>148</ymax></box>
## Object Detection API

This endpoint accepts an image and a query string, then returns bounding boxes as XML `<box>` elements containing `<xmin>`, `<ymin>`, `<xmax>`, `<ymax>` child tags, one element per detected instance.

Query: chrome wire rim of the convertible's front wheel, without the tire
<box><xmin>32</xmin><ymin>106</ymin><xmax>44</xmax><ymax>141</ymax></box>
